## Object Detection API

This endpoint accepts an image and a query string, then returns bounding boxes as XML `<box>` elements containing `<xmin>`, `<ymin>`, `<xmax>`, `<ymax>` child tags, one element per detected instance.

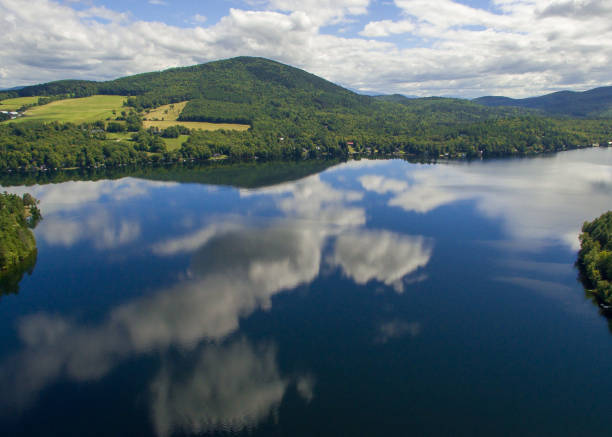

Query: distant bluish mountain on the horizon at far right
<box><xmin>473</xmin><ymin>87</ymin><xmax>612</xmax><ymax>117</ymax></box>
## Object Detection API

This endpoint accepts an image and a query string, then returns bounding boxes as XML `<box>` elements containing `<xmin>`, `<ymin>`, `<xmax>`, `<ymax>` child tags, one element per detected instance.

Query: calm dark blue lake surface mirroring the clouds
<box><xmin>0</xmin><ymin>149</ymin><xmax>612</xmax><ymax>437</ymax></box>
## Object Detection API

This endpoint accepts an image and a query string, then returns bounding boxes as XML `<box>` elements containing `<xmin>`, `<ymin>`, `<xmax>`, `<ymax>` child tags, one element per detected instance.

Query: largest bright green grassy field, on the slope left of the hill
<box><xmin>6</xmin><ymin>96</ymin><xmax>125</xmax><ymax>124</ymax></box>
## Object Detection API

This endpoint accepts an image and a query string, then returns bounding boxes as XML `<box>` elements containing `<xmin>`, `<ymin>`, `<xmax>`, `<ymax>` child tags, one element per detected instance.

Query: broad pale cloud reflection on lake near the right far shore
<box><xmin>359</xmin><ymin>150</ymin><xmax>612</xmax><ymax>250</ymax></box>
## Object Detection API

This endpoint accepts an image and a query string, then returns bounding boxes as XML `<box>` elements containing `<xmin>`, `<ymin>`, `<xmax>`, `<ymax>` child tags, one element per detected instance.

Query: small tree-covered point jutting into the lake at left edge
<box><xmin>0</xmin><ymin>193</ymin><xmax>40</xmax><ymax>275</ymax></box>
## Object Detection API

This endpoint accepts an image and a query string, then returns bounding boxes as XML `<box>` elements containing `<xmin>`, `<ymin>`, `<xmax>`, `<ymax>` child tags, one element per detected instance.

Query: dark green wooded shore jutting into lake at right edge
<box><xmin>578</xmin><ymin>211</ymin><xmax>612</xmax><ymax>307</ymax></box>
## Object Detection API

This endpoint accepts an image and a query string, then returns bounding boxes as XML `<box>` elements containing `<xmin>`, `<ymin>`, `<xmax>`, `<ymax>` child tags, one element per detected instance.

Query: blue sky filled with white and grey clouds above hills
<box><xmin>0</xmin><ymin>0</ymin><xmax>612</xmax><ymax>98</ymax></box>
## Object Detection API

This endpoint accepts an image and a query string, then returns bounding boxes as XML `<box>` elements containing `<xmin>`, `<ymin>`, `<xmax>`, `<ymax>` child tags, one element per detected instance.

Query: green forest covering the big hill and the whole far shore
<box><xmin>0</xmin><ymin>57</ymin><xmax>612</xmax><ymax>171</ymax></box>
